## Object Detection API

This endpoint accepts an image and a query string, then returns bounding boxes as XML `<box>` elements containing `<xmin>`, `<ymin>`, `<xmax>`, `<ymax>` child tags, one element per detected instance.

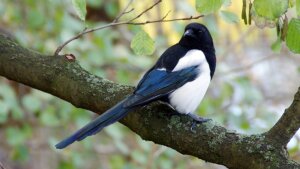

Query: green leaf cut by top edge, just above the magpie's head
<box><xmin>196</xmin><ymin>0</ymin><xmax>224</xmax><ymax>15</ymax></box>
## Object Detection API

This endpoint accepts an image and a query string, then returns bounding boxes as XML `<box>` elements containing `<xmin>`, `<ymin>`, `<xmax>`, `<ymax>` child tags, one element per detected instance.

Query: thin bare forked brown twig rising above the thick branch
<box><xmin>54</xmin><ymin>0</ymin><xmax>204</xmax><ymax>55</ymax></box>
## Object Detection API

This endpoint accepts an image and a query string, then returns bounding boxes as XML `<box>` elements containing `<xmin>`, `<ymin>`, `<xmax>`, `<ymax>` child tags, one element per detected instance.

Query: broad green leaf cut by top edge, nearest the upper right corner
<box><xmin>253</xmin><ymin>0</ymin><xmax>289</xmax><ymax>20</ymax></box>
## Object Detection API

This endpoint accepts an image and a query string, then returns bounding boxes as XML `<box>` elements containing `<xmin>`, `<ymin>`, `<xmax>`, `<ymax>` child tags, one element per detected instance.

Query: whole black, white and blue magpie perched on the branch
<box><xmin>55</xmin><ymin>22</ymin><xmax>216</xmax><ymax>149</ymax></box>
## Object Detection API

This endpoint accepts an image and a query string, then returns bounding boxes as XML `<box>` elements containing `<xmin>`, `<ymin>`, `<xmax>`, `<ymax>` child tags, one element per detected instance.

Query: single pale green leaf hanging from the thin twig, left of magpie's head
<box><xmin>130</xmin><ymin>30</ymin><xmax>155</xmax><ymax>55</ymax></box>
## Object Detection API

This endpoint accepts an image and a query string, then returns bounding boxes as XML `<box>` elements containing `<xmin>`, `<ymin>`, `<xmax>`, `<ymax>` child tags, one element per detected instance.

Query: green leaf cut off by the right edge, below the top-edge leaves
<box><xmin>286</xmin><ymin>18</ymin><xmax>300</xmax><ymax>53</ymax></box>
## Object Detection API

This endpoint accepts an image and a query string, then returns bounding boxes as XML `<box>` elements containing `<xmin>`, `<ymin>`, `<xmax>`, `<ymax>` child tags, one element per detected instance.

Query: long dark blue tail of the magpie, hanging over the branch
<box><xmin>55</xmin><ymin>99</ymin><xmax>131</xmax><ymax>149</ymax></box>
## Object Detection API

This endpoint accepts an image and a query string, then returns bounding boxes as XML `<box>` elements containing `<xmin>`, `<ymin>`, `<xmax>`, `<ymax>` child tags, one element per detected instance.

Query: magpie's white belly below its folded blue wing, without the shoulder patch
<box><xmin>169</xmin><ymin>70</ymin><xmax>211</xmax><ymax>114</ymax></box>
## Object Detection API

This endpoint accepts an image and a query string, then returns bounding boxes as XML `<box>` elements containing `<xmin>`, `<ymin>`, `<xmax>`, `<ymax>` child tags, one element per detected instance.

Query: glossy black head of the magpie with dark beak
<box><xmin>179</xmin><ymin>23</ymin><xmax>214</xmax><ymax>51</ymax></box>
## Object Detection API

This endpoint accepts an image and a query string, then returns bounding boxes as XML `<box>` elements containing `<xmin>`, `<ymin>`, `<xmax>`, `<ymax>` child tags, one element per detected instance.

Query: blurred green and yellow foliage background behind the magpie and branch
<box><xmin>0</xmin><ymin>0</ymin><xmax>300</xmax><ymax>169</ymax></box>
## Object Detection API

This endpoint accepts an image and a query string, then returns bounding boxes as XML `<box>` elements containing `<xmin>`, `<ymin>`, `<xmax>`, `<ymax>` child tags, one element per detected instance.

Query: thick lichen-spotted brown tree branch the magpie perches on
<box><xmin>0</xmin><ymin>35</ymin><xmax>300</xmax><ymax>169</ymax></box>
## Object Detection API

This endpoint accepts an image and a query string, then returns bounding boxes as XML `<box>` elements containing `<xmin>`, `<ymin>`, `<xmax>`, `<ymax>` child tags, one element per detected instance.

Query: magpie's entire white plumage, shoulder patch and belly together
<box><xmin>169</xmin><ymin>50</ymin><xmax>211</xmax><ymax>114</ymax></box>
